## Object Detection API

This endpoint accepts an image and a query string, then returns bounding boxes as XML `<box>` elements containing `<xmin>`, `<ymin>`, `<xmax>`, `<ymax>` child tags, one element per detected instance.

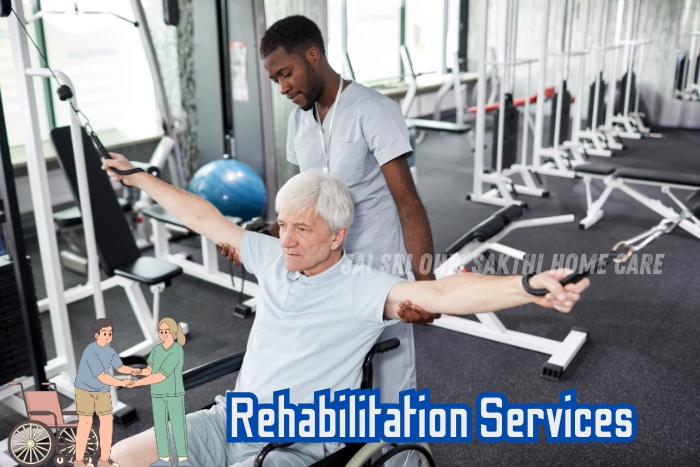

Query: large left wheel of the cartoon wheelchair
<box><xmin>7</xmin><ymin>421</ymin><xmax>56</xmax><ymax>467</ymax></box>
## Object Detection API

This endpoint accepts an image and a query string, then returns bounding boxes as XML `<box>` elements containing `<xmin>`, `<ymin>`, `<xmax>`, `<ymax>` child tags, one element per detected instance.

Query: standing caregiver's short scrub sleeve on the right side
<box><xmin>361</xmin><ymin>96</ymin><xmax>413</xmax><ymax>166</ymax></box>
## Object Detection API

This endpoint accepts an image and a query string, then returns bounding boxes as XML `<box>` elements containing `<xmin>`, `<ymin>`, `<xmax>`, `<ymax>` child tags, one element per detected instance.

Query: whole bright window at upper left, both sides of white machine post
<box><xmin>0</xmin><ymin>0</ymin><xmax>167</xmax><ymax>163</ymax></box>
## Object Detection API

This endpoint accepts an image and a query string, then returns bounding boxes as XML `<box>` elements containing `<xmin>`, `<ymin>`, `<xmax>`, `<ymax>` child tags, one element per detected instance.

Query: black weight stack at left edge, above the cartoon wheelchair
<box><xmin>0</xmin><ymin>256</ymin><xmax>46</xmax><ymax>386</ymax></box>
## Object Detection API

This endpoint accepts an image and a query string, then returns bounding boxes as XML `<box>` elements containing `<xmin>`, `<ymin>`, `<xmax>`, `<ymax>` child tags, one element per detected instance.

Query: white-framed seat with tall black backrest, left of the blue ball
<box><xmin>38</xmin><ymin>127</ymin><xmax>182</xmax><ymax>356</ymax></box>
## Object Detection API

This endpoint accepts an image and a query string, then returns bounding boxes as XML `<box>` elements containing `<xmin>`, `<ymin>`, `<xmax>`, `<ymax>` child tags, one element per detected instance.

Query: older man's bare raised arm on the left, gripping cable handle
<box><xmin>102</xmin><ymin>153</ymin><xmax>245</xmax><ymax>251</ymax></box>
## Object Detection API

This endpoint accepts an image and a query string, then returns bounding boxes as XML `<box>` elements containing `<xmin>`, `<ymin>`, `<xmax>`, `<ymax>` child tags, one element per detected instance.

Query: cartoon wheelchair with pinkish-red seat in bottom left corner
<box><xmin>7</xmin><ymin>382</ymin><xmax>99</xmax><ymax>467</ymax></box>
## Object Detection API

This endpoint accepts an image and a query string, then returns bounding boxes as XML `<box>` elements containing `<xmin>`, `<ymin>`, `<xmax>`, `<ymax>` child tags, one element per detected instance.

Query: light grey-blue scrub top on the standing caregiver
<box><xmin>287</xmin><ymin>81</ymin><xmax>412</xmax><ymax>267</ymax></box>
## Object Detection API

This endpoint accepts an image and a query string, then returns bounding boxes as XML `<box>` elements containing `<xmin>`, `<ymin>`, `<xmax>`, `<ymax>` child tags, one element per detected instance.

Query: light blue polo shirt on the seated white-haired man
<box><xmin>236</xmin><ymin>232</ymin><xmax>403</xmax><ymax>403</ymax></box>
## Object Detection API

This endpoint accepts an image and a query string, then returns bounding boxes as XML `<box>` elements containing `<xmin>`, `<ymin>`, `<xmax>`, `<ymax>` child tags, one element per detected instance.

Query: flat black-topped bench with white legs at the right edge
<box><xmin>574</xmin><ymin>164</ymin><xmax>700</xmax><ymax>238</ymax></box>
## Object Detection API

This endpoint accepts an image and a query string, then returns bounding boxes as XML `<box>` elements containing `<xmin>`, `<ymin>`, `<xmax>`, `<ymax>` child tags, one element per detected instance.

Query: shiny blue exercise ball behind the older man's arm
<box><xmin>187</xmin><ymin>159</ymin><xmax>267</xmax><ymax>221</ymax></box>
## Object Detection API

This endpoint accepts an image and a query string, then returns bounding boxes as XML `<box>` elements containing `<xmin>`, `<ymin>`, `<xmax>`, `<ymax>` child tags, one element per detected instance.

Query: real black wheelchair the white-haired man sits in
<box><xmin>183</xmin><ymin>338</ymin><xmax>435</xmax><ymax>467</ymax></box>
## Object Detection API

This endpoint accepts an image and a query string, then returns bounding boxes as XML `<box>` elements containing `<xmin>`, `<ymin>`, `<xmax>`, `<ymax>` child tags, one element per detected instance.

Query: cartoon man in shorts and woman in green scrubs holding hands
<box><xmin>73</xmin><ymin>318</ymin><xmax>192</xmax><ymax>467</ymax></box>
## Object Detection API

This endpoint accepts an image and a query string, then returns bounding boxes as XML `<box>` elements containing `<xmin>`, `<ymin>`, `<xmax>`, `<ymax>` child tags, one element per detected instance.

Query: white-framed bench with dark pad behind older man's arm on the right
<box><xmin>431</xmin><ymin>204</ymin><xmax>588</xmax><ymax>379</ymax></box>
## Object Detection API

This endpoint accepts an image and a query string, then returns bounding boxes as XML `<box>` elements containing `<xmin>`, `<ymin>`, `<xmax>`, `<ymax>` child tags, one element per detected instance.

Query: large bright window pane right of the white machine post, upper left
<box><xmin>42</xmin><ymin>0</ymin><xmax>160</xmax><ymax>139</ymax></box>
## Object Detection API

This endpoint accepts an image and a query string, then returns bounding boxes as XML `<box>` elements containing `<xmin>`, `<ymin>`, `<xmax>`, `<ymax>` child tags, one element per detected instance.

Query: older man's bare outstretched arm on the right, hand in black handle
<box><xmin>384</xmin><ymin>269</ymin><xmax>590</xmax><ymax>319</ymax></box>
